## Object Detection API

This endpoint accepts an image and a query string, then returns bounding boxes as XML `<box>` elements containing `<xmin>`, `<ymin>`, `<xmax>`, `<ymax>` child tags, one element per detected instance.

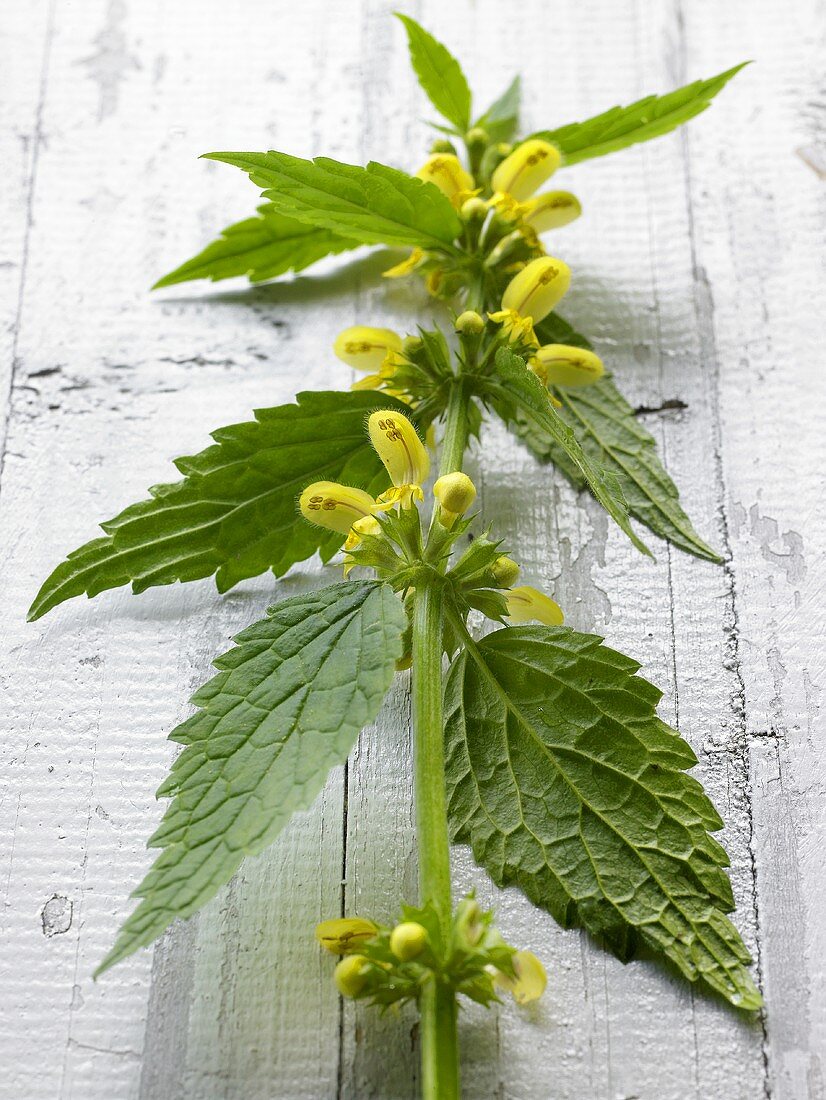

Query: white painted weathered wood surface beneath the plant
<box><xmin>0</xmin><ymin>0</ymin><xmax>826</xmax><ymax>1100</ymax></box>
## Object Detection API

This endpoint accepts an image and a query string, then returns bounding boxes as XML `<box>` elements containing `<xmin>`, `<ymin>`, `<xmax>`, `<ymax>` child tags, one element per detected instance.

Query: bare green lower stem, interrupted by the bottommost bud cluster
<box><xmin>412</xmin><ymin>582</ymin><xmax>459</xmax><ymax>1100</ymax></box>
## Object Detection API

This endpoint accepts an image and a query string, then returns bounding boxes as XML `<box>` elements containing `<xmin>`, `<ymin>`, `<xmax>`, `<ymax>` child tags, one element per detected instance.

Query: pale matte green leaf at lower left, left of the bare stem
<box><xmin>97</xmin><ymin>581</ymin><xmax>406</xmax><ymax>974</ymax></box>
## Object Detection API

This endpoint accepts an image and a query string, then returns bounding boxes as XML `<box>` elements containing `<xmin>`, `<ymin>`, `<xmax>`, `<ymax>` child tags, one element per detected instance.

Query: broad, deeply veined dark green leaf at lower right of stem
<box><xmin>445</xmin><ymin>627</ymin><xmax>760</xmax><ymax>1009</ymax></box>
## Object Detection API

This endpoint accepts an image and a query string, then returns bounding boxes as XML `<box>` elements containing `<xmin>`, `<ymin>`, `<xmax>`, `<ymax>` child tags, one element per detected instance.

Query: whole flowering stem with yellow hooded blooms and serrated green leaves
<box><xmin>31</xmin><ymin>17</ymin><xmax>760</xmax><ymax>1100</ymax></box>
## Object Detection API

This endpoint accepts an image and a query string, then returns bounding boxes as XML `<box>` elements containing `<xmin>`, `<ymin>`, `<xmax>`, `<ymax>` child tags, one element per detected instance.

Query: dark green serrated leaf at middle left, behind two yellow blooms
<box><xmin>29</xmin><ymin>392</ymin><xmax>409</xmax><ymax>619</ymax></box>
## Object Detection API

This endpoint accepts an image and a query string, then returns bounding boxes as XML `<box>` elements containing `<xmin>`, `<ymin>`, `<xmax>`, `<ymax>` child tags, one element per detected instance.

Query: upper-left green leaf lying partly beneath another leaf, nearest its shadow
<box><xmin>152</xmin><ymin>204</ymin><xmax>359</xmax><ymax>290</ymax></box>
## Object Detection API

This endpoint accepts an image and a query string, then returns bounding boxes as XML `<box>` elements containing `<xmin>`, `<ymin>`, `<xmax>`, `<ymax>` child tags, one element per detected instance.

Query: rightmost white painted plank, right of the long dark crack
<box><xmin>686</xmin><ymin>2</ymin><xmax>826</xmax><ymax>1100</ymax></box>
